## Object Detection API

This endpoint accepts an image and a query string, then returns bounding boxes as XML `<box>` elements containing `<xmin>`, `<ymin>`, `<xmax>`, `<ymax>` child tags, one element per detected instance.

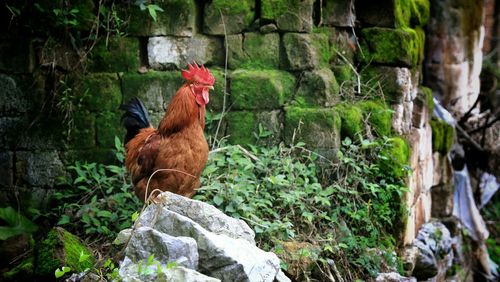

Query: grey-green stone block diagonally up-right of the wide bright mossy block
<box><xmin>281</xmin><ymin>33</ymin><xmax>332</xmax><ymax>70</ymax></box>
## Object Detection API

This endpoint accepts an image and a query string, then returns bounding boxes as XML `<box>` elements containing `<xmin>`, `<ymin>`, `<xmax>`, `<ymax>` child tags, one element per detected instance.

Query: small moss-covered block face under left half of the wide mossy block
<box><xmin>226</xmin><ymin>111</ymin><xmax>256</xmax><ymax>144</ymax></box>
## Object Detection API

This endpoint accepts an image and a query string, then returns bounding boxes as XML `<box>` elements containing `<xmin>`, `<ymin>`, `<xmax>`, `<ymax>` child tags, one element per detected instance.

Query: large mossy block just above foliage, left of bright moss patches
<box><xmin>284</xmin><ymin>107</ymin><xmax>341</xmax><ymax>150</ymax></box>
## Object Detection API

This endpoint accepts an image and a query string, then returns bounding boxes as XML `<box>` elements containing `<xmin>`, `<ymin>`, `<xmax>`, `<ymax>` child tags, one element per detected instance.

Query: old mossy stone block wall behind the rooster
<box><xmin>0</xmin><ymin>0</ymin><xmax>433</xmax><ymax>243</ymax></box>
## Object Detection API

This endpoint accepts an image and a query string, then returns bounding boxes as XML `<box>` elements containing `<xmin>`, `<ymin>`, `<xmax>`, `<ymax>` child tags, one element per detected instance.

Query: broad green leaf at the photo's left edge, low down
<box><xmin>0</xmin><ymin>207</ymin><xmax>38</xmax><ymax>240</ymax></box>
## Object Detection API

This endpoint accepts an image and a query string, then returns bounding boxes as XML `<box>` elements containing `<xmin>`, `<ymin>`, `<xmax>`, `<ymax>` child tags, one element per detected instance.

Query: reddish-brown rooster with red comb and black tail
<box><xmin>120</xmin><ymin>63</ymin><xmax>215</xmax><ymax>201</ymax></box>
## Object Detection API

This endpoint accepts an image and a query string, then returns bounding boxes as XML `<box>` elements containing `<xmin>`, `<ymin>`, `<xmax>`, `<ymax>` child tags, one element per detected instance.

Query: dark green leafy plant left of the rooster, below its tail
<box><xmin>54</xmin><ymin>137</ymin><xmax>141</xmax><ymax>238</ymax></box>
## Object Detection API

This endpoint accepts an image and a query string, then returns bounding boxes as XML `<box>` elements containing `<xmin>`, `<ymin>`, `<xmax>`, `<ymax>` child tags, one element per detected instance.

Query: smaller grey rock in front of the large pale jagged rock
<box><xmin>125</xmin><ymin>227</ymin><xmax>198</xmax><ymax>269</ymax></box>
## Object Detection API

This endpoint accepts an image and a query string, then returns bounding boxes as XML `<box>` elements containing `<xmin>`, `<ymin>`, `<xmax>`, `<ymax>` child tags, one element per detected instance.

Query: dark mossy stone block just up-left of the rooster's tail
<box><xmin>76</xmin><ymin>73</ymin><xmax>122</xmax><ymax>112</ymax></box>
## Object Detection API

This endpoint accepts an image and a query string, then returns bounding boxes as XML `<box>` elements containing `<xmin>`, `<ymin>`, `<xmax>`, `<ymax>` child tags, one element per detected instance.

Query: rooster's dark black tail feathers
<box><xmin>120</xmin><ymin>97</ymin><xmax>150</xmax><ymax>144</ymax></box>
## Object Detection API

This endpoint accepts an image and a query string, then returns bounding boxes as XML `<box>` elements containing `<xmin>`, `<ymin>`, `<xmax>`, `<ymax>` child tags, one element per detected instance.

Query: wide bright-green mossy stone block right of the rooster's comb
<box><xmin>231</xmin><ymin>70</ymin><xmax>295</xmax><ymax>110</ymax></box>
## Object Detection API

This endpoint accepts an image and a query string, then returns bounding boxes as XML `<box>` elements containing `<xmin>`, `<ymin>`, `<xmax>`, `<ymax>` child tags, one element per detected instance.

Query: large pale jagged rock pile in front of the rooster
<box><xmin>116</xmin><ymin>192</ymin><xmax>286</xmax><ymax>281</ymax></box>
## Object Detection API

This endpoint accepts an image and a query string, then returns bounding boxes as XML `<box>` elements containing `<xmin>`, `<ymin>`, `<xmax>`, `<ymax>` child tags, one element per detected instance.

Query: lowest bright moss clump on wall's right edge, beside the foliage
<box><xmin>378</xmin><ymin>137</ymin><xmax>411</xmax><ymax>178</ymax></box>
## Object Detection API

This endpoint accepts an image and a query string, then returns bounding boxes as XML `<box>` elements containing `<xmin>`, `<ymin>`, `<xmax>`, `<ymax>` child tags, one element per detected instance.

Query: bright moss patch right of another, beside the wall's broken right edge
<box><xmin>358</xmin><ymin>100</ymin><xmax>392</xmax><ymax>137</ymax></box>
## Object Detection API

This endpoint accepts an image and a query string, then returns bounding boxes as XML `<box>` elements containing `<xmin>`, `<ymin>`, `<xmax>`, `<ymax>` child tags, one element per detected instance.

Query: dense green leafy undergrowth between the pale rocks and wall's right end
<box><xmin>195</xmin><ymin>138</ymin><xmax>406</xmax><ymax>280</ymax></box>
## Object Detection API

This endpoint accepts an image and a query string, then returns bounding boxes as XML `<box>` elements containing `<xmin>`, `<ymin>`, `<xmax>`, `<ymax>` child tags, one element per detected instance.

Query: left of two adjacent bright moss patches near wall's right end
<box><xmin>336</xmin><ymin>103</ymin><xmax>364</xmax><ymax>139</ymax></box>
